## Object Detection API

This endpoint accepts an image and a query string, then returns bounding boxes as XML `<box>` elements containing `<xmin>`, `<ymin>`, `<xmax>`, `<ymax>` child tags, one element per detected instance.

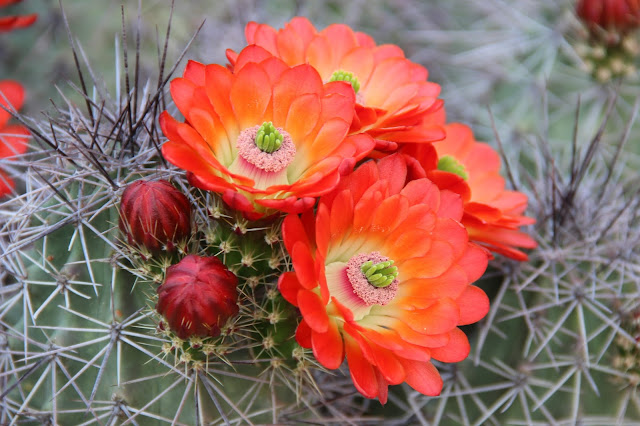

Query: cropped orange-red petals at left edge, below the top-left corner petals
<box><xmin>0</xmin><ymin>80</ymin><xmax>30</xmax><ymax>197</ymax></box>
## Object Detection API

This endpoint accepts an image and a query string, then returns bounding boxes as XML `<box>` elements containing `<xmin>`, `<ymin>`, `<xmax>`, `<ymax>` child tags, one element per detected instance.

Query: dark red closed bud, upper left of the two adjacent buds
<box><xmin>120</xmin><ymin>180</ymin><xmax>191</xmax><ymax>252</ymax></box>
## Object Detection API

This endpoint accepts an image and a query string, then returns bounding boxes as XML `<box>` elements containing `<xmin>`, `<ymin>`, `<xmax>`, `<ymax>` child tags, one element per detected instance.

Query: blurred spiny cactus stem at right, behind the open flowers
<box><xmin>418</xmin><ymin>102</ymin><xmax>640</xmax><ymax>424</ymax></box>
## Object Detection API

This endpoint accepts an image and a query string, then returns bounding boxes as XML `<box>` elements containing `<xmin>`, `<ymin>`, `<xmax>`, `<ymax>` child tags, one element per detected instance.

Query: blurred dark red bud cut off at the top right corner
<box><xmin>576</xmin><ymin>0</ymin><xmax>640</xmax><ymax>32</ymax></box>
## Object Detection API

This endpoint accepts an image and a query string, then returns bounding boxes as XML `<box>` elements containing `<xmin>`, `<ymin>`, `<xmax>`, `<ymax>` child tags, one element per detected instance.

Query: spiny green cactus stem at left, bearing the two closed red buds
<box><xmin>0</xmin><ymin>8</ymin><xmax>313</xmax><ymax>424</ymax></box>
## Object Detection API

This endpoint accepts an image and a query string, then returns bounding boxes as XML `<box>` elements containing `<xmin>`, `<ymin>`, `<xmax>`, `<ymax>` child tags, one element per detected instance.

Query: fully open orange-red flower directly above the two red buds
<box><xmin>160</xmin><ymin>46</ymin><xmax>374</xmax><ymax>219</ymax></box>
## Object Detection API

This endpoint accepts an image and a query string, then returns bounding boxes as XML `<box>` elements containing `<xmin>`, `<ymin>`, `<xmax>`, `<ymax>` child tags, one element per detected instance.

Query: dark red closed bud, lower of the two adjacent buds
<box><xmin>156</xmin><ymin>254</ymin><xmax>238</xmax><ymax>339</ymax></box>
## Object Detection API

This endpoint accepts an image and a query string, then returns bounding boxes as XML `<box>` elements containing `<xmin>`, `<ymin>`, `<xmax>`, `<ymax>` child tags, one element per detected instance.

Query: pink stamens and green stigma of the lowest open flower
<box><xmin>347</xmin><ymin>251</ymin><xmax>398</xmax><ymax>306</ymax></box>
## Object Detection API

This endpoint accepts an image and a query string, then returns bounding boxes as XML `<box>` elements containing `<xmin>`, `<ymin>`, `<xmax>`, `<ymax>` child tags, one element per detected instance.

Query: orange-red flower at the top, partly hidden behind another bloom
<box><xmin>227</xmin><ymin>17</ymin><xmax>444</xmax><ymax>151</ymax></box>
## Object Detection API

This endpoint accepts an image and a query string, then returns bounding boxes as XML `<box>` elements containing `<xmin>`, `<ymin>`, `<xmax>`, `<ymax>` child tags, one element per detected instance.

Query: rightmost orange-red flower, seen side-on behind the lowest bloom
<box><xmin>403</xmin><ymin>121</ymin><xmax>537</xmax><ymax>260</ymax></box>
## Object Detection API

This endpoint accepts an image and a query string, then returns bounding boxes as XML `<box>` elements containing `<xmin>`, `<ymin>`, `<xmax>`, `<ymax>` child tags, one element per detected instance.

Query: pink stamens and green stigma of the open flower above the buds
<box><xmin>236</xmin><ymin>121</ymin><xmax>296</xmax><ymax>173</ymax></box>
